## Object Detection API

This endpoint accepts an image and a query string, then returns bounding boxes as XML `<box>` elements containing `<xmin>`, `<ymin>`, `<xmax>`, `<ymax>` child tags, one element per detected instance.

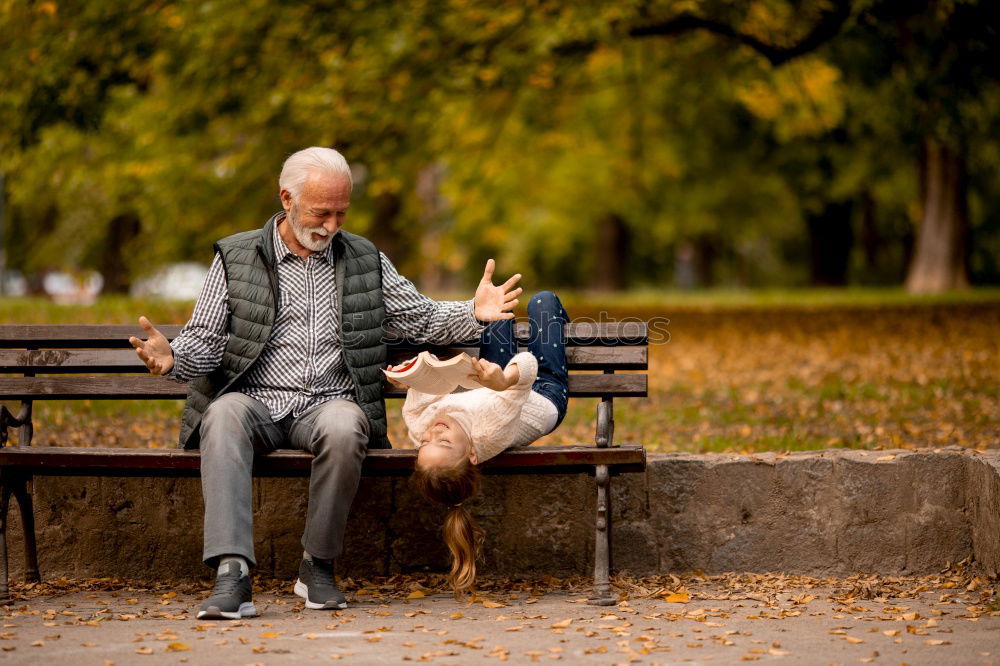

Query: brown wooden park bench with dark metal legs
<box><xmin>0</xmin><ymin>322</ymin><xmax>648</xmax><ymax>605</ymax></box>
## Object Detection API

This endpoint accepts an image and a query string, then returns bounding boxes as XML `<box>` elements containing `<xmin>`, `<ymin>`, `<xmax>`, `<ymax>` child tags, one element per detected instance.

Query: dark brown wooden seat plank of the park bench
<box><xmin>0</xmin><ymin>446</ymin><xmax>646</xmax><ymax>477</ymax></box>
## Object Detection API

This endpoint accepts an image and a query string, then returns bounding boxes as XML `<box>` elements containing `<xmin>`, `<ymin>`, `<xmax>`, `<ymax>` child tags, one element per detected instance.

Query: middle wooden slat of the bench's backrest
<box><xmin>0</xmin><ymin>347</ymin><xmax>648</xmax><ymax>374</ymax></box>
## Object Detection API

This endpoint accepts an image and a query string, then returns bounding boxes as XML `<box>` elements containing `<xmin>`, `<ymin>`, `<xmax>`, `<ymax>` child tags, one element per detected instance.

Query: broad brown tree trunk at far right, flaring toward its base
<box><xmin>906</xmin><ymin>139</ymin><xmax>969</xmax><ymax>294</ymax></box>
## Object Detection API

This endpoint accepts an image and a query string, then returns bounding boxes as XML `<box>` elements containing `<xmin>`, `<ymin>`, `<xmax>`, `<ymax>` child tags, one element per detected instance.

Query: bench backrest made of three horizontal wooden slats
<box><xmin>0</xmin><ymin>321</ymin><xmax>648</xmax><ymax>445</ymax></box>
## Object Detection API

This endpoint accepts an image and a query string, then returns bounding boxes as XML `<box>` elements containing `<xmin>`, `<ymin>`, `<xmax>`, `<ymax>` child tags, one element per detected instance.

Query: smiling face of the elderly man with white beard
<box><xmin>281</xmin><ymin>172</ymin><xmax>351</xmax><ymax>252</ymax></box>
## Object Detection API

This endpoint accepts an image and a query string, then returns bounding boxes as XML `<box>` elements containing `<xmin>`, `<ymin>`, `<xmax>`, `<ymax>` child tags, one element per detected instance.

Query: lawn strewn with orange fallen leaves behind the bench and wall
<box><xmin>0</xmin><ymin>290</ymin><xmax>1000</xmax><ymax>452</ymax></box>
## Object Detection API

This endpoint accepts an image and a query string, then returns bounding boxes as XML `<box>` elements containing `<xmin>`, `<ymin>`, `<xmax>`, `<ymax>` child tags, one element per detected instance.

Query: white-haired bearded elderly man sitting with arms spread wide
<box><xmin>130</xmin><ymin>147</ymin><xmax>521</xmax><ymax>619</ymax></box>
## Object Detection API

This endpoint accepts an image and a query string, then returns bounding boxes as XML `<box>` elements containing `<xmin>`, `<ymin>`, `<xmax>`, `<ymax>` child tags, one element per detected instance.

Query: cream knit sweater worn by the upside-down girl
<box><xmin>403</xmin><ymin>352</ymin><xmax>559</xmax><ymax>463</ymax></box>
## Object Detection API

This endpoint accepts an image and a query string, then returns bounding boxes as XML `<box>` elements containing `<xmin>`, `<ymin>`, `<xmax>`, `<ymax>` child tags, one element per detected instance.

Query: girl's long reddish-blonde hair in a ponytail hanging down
<box><xmin>413</xmin><ymin>457</ymin><xmax>484</xmax><ymax>598</ymax></box>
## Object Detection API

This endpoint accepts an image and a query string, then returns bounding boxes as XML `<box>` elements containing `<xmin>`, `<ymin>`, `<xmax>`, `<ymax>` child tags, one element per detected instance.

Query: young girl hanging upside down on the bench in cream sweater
<box><xmin>390</xmin><ymin>291</ymin><xmax>568</xmax><ymax>595</ymax></box>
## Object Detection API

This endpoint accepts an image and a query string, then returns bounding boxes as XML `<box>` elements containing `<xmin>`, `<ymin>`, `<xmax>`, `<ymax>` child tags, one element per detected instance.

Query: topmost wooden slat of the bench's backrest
<box><xmin>0</xmin><ymin>321</ymin><xmax>648</xmax><ymax>349</ymax></box>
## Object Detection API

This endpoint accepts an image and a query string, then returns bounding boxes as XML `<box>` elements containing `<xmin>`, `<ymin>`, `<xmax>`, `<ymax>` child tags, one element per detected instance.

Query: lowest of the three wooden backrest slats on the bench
<box><xmin>0</xmin><ymin>374</ymin><xmax>647</xmax><ymax>400</ymax></box>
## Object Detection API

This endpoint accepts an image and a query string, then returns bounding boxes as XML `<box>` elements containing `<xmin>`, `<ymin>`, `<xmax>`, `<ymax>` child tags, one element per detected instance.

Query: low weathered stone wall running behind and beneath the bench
<box><xmin>3</xmin><ymin>448</ymin><xmax>1000</xmax><ymax>579</ymax></box>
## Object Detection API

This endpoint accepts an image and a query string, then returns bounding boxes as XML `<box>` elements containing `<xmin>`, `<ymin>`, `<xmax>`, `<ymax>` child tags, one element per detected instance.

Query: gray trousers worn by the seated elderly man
<box><xmin>201</xmin><ymin>393</ymin><xmax>369</xmax><ymax>567</ymax></box>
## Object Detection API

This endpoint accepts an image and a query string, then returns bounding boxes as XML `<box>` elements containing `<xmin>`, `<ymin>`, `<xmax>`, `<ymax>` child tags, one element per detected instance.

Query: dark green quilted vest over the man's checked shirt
<box><xmin>180</xmin><ymin>213</ymin><xmax>389</xmax><ymax>449</ymax></box>
